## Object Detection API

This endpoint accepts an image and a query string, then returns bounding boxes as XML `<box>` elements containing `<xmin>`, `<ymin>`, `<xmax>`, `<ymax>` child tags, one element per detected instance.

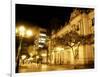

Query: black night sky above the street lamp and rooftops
<box><xmin>16</xmin><ymin>4</ymin><xmax>72</xmax><ymax>29</ymax></box>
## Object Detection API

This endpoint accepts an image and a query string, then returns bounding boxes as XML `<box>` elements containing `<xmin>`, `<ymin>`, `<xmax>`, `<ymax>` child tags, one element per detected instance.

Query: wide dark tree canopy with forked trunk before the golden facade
<box><xmin>53</xmin><ymin>31</ymin><xmax>94</xmax><ymax>65</ymax></box>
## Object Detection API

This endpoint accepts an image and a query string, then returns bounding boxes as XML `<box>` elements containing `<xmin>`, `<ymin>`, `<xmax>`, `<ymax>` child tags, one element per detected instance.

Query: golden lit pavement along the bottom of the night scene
<box><xmin>19</xmin><ymin>63</ymin><xmax>93</xmax><ymax>73</ymax></box>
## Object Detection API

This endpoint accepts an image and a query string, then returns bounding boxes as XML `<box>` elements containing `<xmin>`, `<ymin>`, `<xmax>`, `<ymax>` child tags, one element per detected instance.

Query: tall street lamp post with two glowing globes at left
<box><xmin>16</xmin><ymin>26</ymin><xmax>32</xmax><ymax>73</ymax></box>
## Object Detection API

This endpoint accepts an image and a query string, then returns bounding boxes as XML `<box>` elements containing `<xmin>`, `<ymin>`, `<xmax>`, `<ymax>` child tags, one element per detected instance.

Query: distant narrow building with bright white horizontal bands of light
<box><xmin>37</xmin><ymin>28</ymin><xmax>48</xmax><ymax>63</ymax></box>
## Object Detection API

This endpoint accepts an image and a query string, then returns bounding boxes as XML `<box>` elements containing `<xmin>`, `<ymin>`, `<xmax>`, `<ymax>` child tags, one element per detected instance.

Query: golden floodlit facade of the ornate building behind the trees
<box><xmin>51</xmin><ymin>9</ymin><xmax>94</xmax><ymax>64</ymax></box>
